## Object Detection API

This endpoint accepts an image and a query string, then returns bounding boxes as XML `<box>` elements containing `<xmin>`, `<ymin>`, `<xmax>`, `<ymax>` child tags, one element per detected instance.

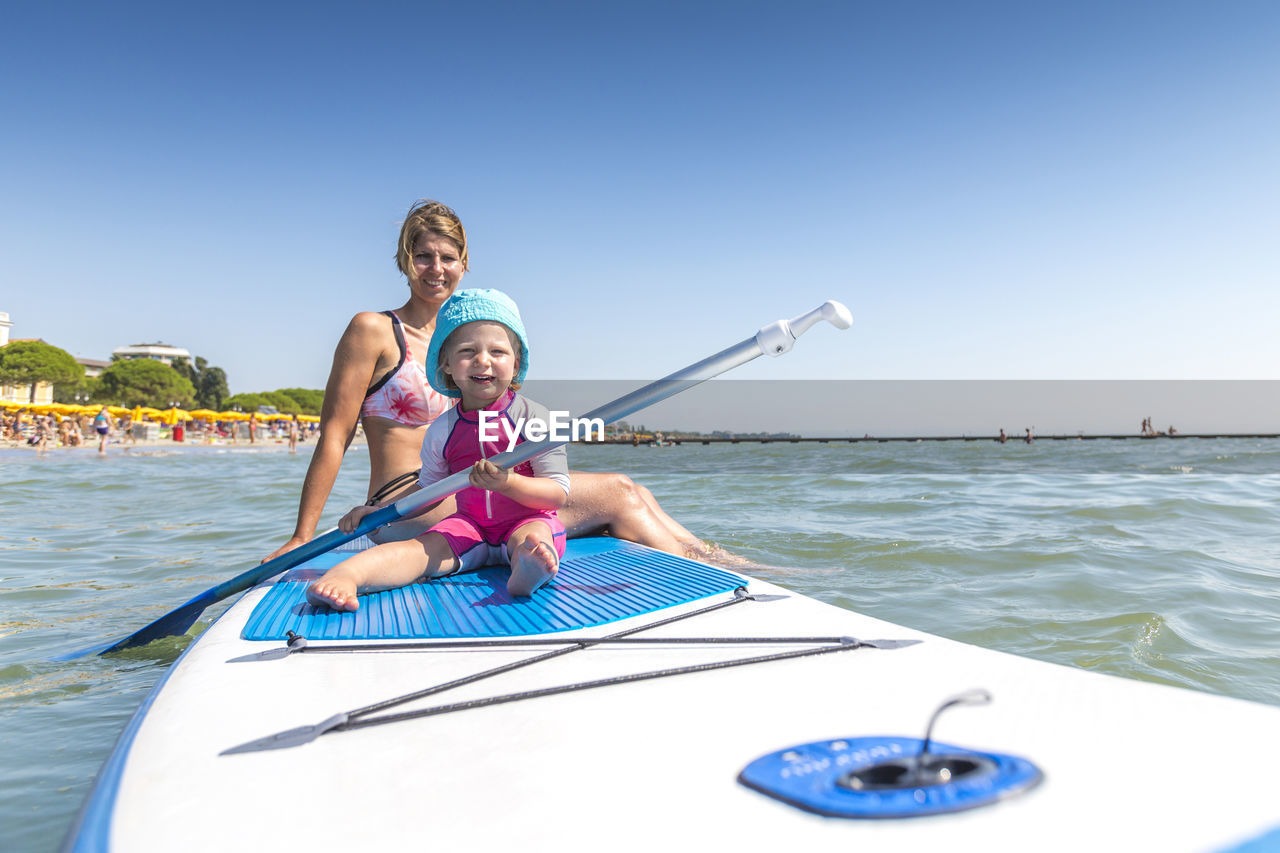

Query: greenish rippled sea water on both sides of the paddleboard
<box><xmin>0</xmin><ymin>439</ymin><xmax>1280</xmax><ymax>852</ymax></box>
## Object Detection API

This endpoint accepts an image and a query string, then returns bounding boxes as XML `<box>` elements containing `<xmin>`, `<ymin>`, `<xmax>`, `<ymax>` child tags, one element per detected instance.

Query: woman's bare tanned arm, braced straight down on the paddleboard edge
<box><xmin>265</xmin><ymin>311</ymin><xmax>389</xmax><ymax>560</ymax></box>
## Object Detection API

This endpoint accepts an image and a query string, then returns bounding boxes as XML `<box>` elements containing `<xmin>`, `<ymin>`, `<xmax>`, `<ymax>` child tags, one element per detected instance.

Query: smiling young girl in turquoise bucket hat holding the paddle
<box><xmin>307</xmin><ymin>289</ymin><xmax>568</xmax><ymax>610</ymax></box>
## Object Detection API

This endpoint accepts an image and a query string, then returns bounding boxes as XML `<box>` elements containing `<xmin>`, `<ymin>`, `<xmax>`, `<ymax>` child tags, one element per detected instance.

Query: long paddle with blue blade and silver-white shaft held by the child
<box><xmin>85</xmin><ymin>301</ymin><xmax>852</xmax><ymax>660</ymax></box>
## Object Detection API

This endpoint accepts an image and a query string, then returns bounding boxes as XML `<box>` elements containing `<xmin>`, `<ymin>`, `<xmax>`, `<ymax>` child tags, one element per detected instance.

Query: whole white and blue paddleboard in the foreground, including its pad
<box><xmin>67</xmin><ymin>539</ymin><xmax>1280</xmax><ymax>853</ymax></box>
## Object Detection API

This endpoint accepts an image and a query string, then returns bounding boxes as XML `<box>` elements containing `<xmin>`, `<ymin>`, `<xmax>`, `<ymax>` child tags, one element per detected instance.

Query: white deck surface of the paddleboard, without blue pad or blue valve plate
<box><xmin>68</xmin><ymin>540</ymin><xmax>1280</xmax><ymax>853</ymax></box>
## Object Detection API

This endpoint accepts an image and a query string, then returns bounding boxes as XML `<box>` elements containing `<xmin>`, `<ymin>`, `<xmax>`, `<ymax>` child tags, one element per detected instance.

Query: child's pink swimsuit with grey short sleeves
<box><xmin>419</xmin><ymin>391</ymin><xmax>568</xmax><ymax>529</ymax></box>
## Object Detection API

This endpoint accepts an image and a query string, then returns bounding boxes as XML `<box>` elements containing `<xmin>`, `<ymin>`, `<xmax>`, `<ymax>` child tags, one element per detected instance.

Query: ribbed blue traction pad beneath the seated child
<box><xmin>241</xmin><ymin>537</ymin><xmax>745</xmax><ymax>640</ymax></box>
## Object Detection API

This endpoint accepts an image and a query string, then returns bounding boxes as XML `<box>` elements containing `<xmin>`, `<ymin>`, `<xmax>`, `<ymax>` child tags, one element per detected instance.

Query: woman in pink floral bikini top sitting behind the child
<box><xmin>266</xmin><ymin>200</ymin><xmax>728</xmax><ymax>561</ymax></box>
